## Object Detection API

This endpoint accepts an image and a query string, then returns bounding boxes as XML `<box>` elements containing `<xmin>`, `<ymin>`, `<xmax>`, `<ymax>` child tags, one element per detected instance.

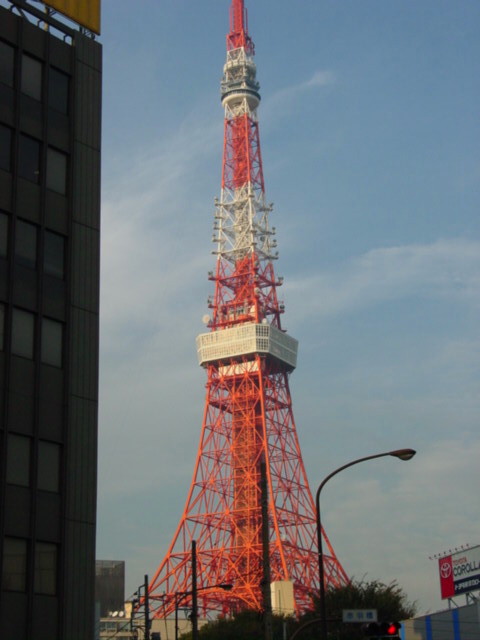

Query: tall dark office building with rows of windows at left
<box><xmin>0</xmin><ymin>0</ymin><xmax>101</xmax><ymax>640</ymax></box>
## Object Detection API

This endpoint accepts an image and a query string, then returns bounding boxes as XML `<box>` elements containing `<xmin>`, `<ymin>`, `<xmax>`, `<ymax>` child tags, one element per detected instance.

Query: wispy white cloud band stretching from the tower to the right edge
<box><xmin>285</xmin><ymin>239</ymin><xmax>480</xmax><ymax>317</ymax></box>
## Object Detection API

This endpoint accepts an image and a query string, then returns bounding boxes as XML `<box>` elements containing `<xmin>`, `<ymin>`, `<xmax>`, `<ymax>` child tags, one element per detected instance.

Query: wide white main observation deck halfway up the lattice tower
<box><xmin>196</xmin><ymin>322</ymin><xmax>298</xmax><ymax>371</ymax></box>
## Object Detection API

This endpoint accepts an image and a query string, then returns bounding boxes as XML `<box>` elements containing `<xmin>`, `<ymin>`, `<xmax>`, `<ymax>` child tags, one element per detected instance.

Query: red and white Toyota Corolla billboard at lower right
<box><xmin>438</xmin><ymin>546</ymin><xmax>480</xmax><ymax>599</ymax></box>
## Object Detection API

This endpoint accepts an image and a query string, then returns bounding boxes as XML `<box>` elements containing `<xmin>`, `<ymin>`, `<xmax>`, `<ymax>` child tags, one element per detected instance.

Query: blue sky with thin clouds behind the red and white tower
<box><xmin>97</xmin><ymin>0</ymin><xmax>480</xmax><ymax>612</ymax></box>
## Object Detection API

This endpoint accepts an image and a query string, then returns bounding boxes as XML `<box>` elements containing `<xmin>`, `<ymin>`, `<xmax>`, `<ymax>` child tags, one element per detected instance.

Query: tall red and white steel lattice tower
<box><xmin>149</xmin><ymin>0</ymin><xmax>348</xmax><ymax>617</ymax></box>
